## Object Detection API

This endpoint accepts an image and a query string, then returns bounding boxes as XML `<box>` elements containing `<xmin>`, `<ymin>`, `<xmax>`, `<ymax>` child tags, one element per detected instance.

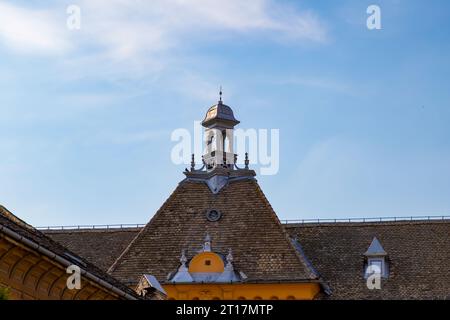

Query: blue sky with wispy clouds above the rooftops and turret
<box><xmin>0</xmin><ymin>0</ymin><xmax>450</xmax><ymax>226</ymax></box>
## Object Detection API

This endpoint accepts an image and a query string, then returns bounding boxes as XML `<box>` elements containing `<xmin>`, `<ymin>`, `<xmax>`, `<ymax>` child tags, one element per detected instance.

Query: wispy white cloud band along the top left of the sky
<box><xmin>0</xmin><ymin>0</ymin><xmax>326</xmax><ymax>61</ymax></box>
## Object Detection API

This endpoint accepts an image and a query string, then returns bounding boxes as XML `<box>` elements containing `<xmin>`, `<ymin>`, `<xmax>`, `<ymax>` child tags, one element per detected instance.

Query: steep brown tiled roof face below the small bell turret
<box><xmin>110</xmin><ymin>179</ymin><xmax>316</xmax><ymax>283</ymax></box>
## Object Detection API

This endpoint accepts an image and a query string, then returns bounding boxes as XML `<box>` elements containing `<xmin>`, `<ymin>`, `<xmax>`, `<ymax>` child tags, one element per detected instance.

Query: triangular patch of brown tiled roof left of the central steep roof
<box><xmin>42</xmin><ymin>228</ymin><xmax>142</xmax><ymax>271</ymax></box>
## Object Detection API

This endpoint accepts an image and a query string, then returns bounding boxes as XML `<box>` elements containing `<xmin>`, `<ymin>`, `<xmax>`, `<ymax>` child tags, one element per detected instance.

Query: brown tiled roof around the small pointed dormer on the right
<box><xmin>286</xmin><ymin>221</ymin><xmax>450</xmax><ymax>299</ymax></box>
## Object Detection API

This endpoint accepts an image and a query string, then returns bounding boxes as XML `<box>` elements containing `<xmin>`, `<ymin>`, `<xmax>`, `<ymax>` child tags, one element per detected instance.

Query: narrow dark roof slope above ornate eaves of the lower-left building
<box><xmin>0</xmin><ymin>206</ymin><xmax>140</xmax><ymax>299</ymax></box>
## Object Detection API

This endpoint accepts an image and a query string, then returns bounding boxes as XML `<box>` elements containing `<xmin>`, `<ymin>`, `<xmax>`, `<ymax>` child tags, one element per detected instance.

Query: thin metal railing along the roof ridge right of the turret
<box><xmin>280</xmin><ymin>215</ymin><xmax>450</xmax><ymax>224</ymax></box>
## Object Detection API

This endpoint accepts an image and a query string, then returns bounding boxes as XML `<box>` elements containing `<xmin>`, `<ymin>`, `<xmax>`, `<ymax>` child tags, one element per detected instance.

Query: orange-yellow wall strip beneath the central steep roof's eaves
<box><xmin>164</xmin><ymin>283</ymin><xmax>320</xmax><ymax>300</ymax></box>
